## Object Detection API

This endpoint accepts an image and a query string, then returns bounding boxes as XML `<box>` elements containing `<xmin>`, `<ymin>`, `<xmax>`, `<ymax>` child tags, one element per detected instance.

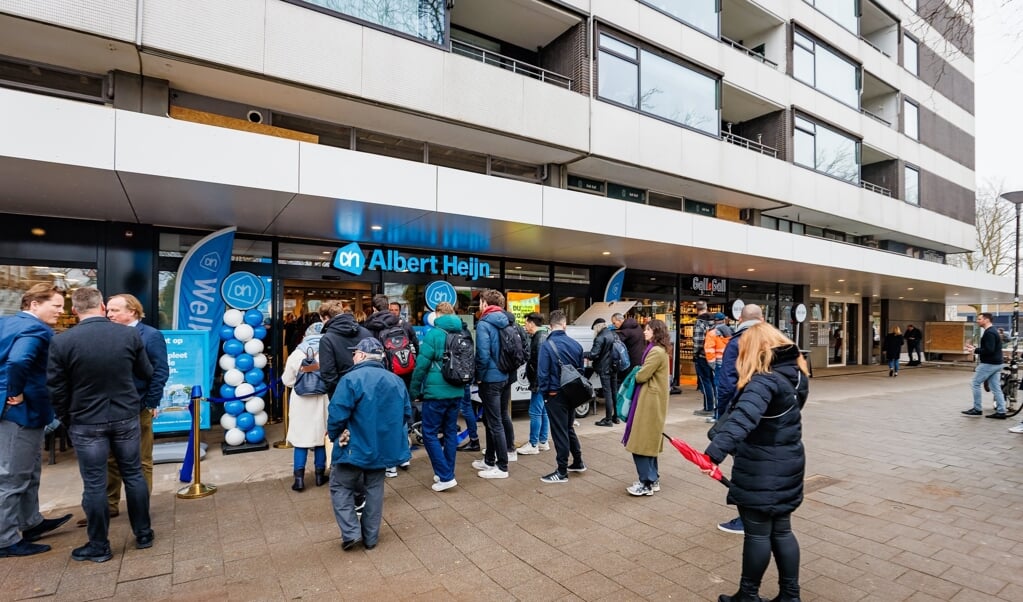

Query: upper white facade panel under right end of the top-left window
<box><xmin>362</xmin><ymin>28</ymin><xmax>446</xmax><ymax>115</ymax></box>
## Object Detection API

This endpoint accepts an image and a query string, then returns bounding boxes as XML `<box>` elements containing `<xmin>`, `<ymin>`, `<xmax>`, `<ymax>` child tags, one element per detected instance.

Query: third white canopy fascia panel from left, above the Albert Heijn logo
<box><xmin>299</xmin><ymin>142</ymin><xmax>438</xmax><ymax>211</ymax></box>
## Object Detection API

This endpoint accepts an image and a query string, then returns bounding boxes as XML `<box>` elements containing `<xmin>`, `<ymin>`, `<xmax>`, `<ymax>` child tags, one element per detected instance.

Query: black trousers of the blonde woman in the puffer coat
<box><xmin>739</xmin><ymin>506</ymin><xmax>799</xmax><ymax>599</ymax></box>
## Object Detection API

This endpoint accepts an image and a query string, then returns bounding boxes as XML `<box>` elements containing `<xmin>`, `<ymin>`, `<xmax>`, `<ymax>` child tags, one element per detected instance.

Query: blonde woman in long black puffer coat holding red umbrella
<box><xmin>706</xmin><ymin>323</ymin><xmax>808</xmax><ymax>602</ymax></box>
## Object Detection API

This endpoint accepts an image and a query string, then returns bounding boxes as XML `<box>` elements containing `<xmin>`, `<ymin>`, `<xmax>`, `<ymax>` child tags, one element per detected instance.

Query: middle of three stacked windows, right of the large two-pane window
<box><xmin>792</xmin><ymin>31</ymin><xmax>860</xmax><ymax>109</ymax></box>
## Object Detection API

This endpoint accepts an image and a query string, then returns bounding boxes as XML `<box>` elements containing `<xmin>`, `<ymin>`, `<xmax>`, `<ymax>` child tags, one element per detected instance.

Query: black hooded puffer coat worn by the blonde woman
<box><xmin>705</xmin><ymin>345</ymin><xmax>809</xmax><ymax>516</ymax></box>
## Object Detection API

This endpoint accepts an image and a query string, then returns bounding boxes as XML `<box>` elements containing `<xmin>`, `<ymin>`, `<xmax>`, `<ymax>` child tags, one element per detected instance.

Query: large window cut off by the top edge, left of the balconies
<box><xmin>291</xmin><ymin>0</ymin><xmax>448</xmax><ymax>44</ymax></box>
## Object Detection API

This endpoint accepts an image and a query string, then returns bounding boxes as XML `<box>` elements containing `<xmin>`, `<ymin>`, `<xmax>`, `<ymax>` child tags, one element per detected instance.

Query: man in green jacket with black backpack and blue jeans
<box><xmin>411</xmin><ymin>301</ymin><xmax>468</xmax><ymax>491</ymax></box>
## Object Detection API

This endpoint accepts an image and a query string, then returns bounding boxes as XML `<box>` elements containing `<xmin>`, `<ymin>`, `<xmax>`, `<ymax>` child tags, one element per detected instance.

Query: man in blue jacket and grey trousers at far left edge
<box><xmin>0</xmin><ymin>284</ymin><xmax>72</xmax><ymax>558</ymax></box>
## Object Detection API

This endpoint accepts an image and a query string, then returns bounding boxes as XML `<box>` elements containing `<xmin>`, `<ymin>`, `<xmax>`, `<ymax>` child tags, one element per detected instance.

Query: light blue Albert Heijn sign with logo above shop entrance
<box><xmin>330</xmin><ymin>243</ymin><xmax>490</xmax><ymax>281</ymax></box>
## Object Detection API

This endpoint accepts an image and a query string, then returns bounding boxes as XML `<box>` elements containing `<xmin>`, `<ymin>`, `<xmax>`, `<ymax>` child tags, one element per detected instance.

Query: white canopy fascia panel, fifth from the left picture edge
<box><xmin>541</xmin><ymin>186</ymin><xmax>633</xmax><ymax>237</ymax></box>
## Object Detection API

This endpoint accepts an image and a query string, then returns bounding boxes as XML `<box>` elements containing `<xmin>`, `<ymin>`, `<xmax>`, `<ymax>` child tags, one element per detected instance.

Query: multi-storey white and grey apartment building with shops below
<box><xmin>0</xmin><ymin>0</ymin><xmax>1012</xmax><ymax>376</ymax></box>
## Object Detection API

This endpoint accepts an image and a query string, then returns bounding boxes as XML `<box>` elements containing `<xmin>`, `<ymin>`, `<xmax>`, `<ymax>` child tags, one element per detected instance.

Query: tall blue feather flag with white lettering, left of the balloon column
<box><xmin>174</xmin><ymin>226</ymin><xmax>235</xmax><ymax>385</ymax></box>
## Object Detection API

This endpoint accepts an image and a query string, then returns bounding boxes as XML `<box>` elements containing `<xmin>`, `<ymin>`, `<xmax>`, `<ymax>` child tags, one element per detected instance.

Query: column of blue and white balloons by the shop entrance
<box><xmin>219</xmin><ymin>308</ymin><xmax>267</xmax><ymax>445</ymax></box>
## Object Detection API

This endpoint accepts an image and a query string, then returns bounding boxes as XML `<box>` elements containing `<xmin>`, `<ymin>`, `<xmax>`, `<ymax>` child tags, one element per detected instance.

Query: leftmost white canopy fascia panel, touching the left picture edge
<box><xmin>0</xmin><ymin>88</ymin><xmax>115</xmax><ymax>169</ymax></box>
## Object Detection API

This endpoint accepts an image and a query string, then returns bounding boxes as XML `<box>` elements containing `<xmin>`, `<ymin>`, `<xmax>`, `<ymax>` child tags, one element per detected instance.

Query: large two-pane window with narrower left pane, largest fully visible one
<box><xmin>597</xmin><ymin>34</ymin><xmax>720</xmax><ymax>136</ymax></box>
